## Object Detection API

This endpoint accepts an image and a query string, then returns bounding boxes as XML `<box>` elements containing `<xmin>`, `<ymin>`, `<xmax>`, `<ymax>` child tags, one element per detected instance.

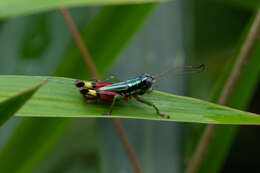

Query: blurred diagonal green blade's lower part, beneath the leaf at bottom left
<box><xmin>0</xmin><ymin>118</ymin><xmax>69</xmax><ymax>173</ymax></box>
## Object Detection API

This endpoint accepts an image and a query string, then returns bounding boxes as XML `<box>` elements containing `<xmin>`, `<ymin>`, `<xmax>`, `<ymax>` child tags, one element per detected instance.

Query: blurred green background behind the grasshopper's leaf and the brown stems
<box><xmin>0</xmin><ymin>0</ymin><xmax>260</xmax><ymax>173</ymax></box>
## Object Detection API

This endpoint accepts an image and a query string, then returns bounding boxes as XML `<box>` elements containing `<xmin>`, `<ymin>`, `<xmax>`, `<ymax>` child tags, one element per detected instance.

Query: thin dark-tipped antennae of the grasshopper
<box><xmin>153</xmin><ymin>64</ymin><xmax>205</xmax><ymax>81</ymax></box>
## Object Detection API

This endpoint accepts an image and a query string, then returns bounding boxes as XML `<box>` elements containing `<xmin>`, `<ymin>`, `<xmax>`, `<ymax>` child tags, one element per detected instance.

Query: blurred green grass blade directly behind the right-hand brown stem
<box><xmin>190</xmin><ymin>10</ymin><xmax>260</xmax><ymax>173</ymax></box>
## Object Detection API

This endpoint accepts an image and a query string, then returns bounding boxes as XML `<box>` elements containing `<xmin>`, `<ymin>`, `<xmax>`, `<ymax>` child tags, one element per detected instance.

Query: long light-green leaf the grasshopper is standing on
<box><xmin>0</xmin><ymin>76</ymin><xmax>260</xmax><ymax>124</ymax></box>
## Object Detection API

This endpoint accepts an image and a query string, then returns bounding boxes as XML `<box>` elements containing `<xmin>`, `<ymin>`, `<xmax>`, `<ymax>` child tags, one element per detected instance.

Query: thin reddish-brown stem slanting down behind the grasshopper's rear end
<box><xmin>60</xmin><ymin>8</ymin><xmax>142</xmax><ymax>173</ymax></box>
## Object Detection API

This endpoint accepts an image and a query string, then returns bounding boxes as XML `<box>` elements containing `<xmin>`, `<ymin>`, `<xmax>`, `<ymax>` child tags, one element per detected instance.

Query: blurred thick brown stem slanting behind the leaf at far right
<box><xmin>187</xmin><ymin>8</ymin><xmax>260</xmax><ymax>173</ymax></box>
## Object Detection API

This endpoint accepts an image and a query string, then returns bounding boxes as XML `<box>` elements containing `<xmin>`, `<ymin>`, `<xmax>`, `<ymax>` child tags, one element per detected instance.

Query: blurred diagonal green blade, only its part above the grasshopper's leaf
<box><xmin>55</xmin><ymin>3</ymin><xmax>156</xmax><ymax>79</ymax></box>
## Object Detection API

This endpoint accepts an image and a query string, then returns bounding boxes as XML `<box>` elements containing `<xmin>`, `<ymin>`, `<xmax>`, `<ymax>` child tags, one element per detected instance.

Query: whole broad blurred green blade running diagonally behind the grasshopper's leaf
<box><xmin>0</xmin><ymin>4</ymin><xmax>155</xmax><ymax>173</ymax></box>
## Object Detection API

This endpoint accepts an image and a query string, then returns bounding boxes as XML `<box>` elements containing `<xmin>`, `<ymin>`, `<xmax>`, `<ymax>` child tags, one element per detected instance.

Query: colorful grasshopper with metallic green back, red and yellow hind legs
<box><xmin>75</xmin><ymin>64</ymin><xmax>205</xmax><ymax>118</ymax></box>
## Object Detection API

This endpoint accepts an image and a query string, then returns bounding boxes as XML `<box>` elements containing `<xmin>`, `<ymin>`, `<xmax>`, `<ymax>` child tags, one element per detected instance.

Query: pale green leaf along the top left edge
<box><xmin>0</xmin><ymin>0</ymin><xmax>164</xmax><ymax>18</ymax></box>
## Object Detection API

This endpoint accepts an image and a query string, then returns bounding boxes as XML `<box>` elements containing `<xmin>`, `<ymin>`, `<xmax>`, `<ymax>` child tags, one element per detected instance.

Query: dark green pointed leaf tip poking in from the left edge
<box><xmin>0</xmin><ymin>80</ymin><xmax>44</xmax><ymax>127</ymax></box>
